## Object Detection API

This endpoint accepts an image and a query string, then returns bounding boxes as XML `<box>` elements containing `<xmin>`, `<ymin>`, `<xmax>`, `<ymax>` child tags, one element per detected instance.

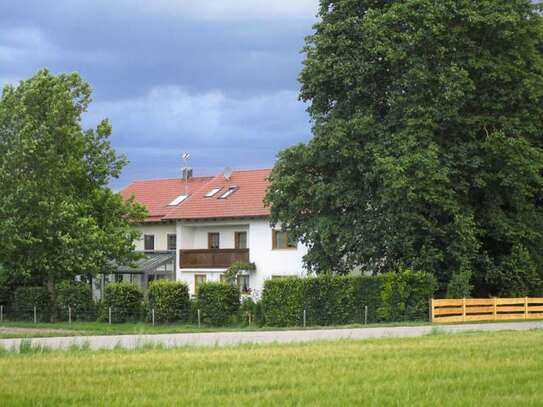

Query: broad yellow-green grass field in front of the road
<box><xmin>0</xmin><ymin>331</ymin><xmax>543</xmax><ymax>406</ymax></box>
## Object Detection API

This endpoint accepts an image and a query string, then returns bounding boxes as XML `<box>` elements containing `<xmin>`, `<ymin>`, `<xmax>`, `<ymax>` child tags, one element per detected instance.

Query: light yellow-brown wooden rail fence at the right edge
<box><xmin>436</xmin><ymin>297</ymin><xmax>543</xmax><ymax>323</ymax></box>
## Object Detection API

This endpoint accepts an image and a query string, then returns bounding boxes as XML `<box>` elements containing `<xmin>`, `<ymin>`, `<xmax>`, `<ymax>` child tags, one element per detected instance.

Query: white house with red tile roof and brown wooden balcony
<box><xmin>117</xmin><ymin>169</ymin><xmax>306</xmax><ymax>297</ymax></box>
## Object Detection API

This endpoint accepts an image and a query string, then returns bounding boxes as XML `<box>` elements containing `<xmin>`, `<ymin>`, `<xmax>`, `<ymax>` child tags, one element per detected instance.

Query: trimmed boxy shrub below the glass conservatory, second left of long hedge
<box><xmin>149</xmin><ymin>280</ymin><xmax>190</xmax><ymax>322</ymax></box>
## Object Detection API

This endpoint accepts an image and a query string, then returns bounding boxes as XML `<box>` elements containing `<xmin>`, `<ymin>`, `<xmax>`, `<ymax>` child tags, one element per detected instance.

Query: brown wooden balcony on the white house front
<box><xmin>179</xmin><ymin>249</ymin><xmax>249</xmax><ymax>269</ymax></box>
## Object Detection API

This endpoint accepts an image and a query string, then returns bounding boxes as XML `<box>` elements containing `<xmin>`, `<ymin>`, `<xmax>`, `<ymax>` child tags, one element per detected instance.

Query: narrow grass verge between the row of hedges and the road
<box><xmin>0</xmin><ymin>321</ymin><xmax>434</xmax><ymax>339</ymax></box>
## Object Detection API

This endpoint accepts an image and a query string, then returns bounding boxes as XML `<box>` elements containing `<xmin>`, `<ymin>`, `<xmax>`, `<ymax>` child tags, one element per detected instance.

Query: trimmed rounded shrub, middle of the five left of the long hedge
<box><xmin>101</xmin><ymin>283</ymin><xmax>143</xmax><ymax>322</ymax></box>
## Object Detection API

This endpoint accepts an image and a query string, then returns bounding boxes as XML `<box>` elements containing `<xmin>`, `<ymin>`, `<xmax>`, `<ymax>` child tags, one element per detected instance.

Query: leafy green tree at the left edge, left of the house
<box><xmin>0</xmin><ymin>70</ymin><xmax>145</xmax><ymax>302</ymax></box>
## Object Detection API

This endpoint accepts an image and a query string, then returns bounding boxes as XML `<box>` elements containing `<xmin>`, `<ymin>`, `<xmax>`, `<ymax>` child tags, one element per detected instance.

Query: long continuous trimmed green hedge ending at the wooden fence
<box><xmin>262</xmin><ymin>270</ymin><xmax>436</xmax><ymax>326</ymax></box>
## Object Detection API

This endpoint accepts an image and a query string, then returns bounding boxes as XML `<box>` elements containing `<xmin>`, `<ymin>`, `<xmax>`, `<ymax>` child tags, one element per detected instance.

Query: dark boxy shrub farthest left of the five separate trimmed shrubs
<box><xmin>12</xmin><ymin>287</ymin><xmax>51</xmax><ymax>321</ymax></box>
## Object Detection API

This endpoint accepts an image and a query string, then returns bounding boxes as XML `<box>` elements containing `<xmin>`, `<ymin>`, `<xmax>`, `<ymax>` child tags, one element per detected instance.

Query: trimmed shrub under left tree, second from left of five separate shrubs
<box><xmin>56</xmin><ymin>282</ymin><xmax>96</xmax><ymax>321</ymax></box>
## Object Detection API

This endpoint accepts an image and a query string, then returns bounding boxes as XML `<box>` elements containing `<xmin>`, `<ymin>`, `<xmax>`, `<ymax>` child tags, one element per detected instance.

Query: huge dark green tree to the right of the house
<box><xmin>267</xmin><ymin>0</ymin><xmax>543</xmax><ymax>295</ymax></box>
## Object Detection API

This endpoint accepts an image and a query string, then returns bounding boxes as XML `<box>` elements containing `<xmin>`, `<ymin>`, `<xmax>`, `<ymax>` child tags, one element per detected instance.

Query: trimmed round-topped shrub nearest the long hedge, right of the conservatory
<box><xmin>198</xmin><ymin>282</ymin><xmax>240</xmax><ymax>326</ymax></box>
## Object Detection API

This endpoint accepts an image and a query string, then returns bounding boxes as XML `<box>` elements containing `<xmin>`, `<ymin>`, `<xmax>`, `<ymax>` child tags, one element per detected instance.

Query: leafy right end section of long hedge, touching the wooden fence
<box><xmin>377</xmin><ymin>270</ymin><xmax>437</xmax><ymax>322</ymax></box>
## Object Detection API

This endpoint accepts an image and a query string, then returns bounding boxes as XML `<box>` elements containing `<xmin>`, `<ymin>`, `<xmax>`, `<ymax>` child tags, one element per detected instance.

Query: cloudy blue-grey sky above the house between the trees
<box><xmin>0</xmin><ymin>0</ymin><xmax>317</xmax><ymax>189</ymax></box>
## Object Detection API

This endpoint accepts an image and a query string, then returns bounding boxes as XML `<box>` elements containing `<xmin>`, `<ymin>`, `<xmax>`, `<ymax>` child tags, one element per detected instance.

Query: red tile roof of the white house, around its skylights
<box><xmin>121</xmin><ymin>169</ymin><xmax>271</xmax><ymax>222</ymax></box>
